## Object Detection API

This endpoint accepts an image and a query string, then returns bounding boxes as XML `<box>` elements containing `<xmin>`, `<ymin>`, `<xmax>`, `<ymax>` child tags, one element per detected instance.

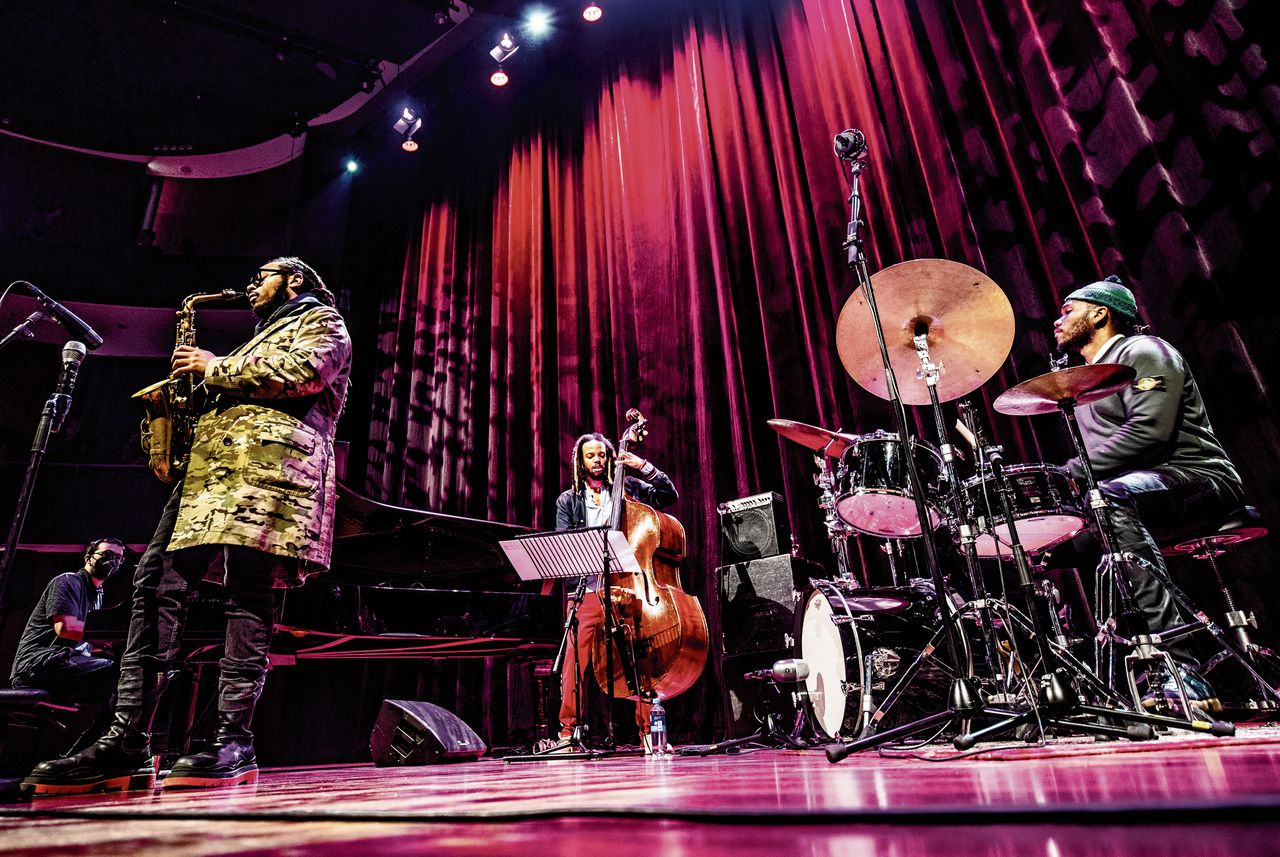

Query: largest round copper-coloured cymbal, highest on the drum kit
<box><xmin>836</xmin><ymin>258</ymin><xmax>1014</xmax><ymax>404</ymax></box>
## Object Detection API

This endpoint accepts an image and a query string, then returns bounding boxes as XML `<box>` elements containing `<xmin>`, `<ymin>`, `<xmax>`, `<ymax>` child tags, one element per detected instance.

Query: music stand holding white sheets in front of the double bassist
<box><xmin>498</xmin><ymin>527</ymin><xmax>643</xmax><ymax>762</ymax></box>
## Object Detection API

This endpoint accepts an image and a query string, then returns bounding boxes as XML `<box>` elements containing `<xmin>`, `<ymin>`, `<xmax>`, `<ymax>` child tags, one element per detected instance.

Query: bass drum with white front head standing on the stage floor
<box><xmin>796</xmin><ymin>581</ymin><xmax>970</xmax><ymax>741</ymax></box>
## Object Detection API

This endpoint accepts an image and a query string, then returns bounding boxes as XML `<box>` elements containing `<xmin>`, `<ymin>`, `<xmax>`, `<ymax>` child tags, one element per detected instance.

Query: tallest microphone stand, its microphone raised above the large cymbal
<box><xmin>827</xmin><ymin>132</ymin><xmax>982</xmax><ymax>762</ymax></box>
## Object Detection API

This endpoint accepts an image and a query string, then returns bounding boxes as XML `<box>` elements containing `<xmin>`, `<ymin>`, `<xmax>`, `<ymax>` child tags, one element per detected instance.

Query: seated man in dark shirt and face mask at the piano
<box><xmin>9</xmin><ymin>539</ymin><xmax>124</xmax><ymax>702</ymax></box>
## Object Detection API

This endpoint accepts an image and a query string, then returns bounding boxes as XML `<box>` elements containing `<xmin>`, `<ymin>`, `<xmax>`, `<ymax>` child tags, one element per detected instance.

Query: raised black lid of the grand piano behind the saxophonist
<box><xmin>330</xmin><ymin>482</ymin><xmax>532</xmax><ymax>590</ymax></box>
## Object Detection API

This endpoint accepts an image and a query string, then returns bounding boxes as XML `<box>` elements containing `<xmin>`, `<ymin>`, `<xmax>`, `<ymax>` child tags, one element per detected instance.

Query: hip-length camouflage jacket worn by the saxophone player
<box><xmin>169</xmin><ymin>295</ymin><xmax>351</xmax><ymax>583</ymax></box>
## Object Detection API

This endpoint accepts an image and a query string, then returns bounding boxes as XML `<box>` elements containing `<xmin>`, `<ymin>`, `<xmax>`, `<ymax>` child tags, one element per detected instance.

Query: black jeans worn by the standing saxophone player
<box><xmin>116</xmin><ymin>485</ymin><xmax>280</xmax><ymax>735</ymax></box>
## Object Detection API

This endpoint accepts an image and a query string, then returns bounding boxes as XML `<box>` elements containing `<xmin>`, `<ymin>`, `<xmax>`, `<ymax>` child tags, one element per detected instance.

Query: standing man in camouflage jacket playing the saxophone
<box><xmin>23</xmin><ymin>257</ymin><xmax>351</xmax><ymax>796</ymax></box>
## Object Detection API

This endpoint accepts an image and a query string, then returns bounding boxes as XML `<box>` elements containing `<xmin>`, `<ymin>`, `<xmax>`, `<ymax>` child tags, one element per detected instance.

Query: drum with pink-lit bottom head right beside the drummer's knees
<box><xmin>964</xmin><ymin>464</ymin><xmax>1085</xmax><ymax>559</ymax></box>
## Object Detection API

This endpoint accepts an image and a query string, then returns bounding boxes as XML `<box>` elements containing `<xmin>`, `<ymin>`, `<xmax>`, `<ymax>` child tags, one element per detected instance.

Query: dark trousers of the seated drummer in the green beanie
<box><xmin>1075</xmin><ymin>467</ymin><xmax>1244</xmax><ymax>663</ymax></box>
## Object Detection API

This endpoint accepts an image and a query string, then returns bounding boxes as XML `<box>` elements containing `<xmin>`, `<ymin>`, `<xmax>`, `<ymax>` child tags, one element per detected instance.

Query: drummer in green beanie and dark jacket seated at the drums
<box><xmin>1053</xmin><ymin>276</ymin><xmax>1244</xmax><ymax>712</ymax></box>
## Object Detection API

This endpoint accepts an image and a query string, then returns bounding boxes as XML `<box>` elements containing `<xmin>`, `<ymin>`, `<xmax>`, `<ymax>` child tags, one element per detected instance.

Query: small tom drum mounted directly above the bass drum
<box><xmin>836</xmin><ymin>431</ymin><xmax>945</xmax><ymax>539</ymax></box>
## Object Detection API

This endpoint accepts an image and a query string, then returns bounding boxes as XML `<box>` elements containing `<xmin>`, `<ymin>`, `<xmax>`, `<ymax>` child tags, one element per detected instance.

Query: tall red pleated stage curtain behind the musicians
<box><xmin>353</xmin><ymin>0</ymin><xmax>1280</xmax><ymax>736</ymax></box>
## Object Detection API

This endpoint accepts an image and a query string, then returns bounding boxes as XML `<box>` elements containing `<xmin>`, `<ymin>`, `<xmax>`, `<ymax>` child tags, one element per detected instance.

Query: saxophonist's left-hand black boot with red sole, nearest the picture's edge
<box><xmin>22</xmin><ymin>711</ymin><xmax>156</xmax><ymax>797</ymax></box>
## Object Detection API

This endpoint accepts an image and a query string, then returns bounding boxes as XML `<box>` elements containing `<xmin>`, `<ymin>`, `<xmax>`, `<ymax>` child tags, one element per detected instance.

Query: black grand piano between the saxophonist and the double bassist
<box><xmin>77</xmin><ymin>482</ymin><xmax>561</xmax><ymax>665</ymax></box>
